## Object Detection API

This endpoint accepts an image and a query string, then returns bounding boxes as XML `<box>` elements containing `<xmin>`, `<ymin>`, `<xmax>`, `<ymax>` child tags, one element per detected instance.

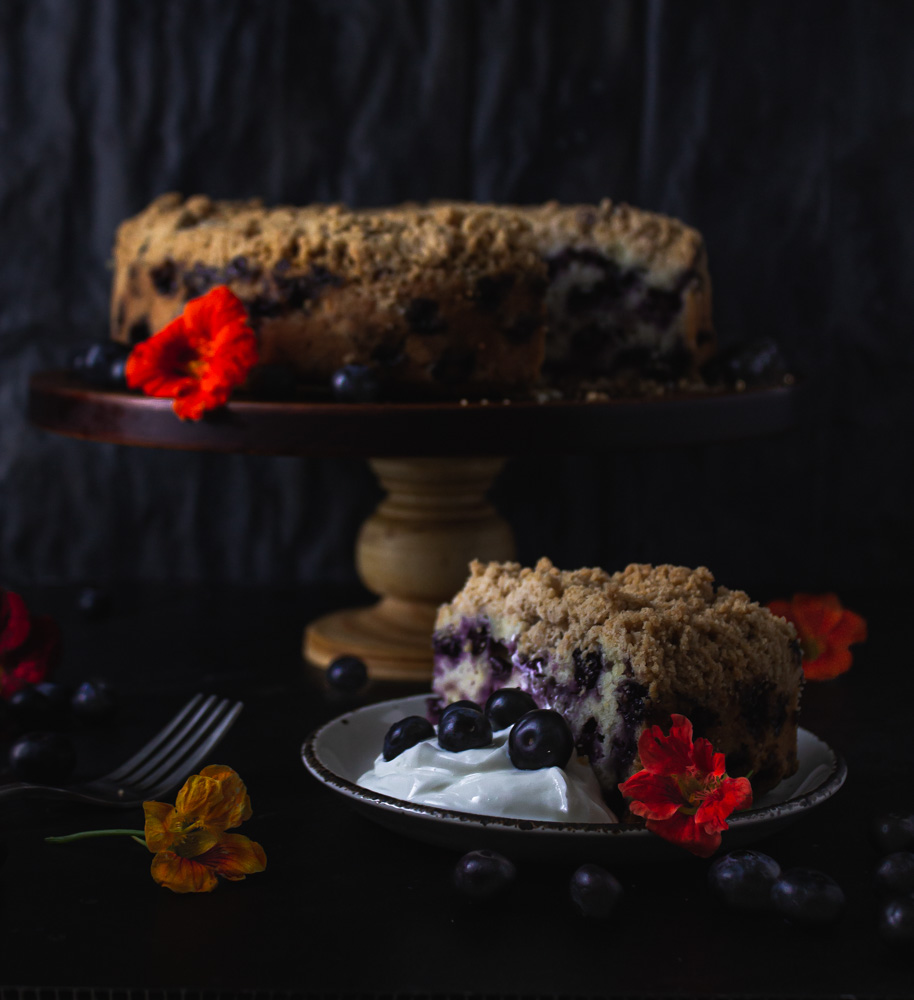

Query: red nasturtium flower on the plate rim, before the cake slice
<box><xmin>619</xmin><ymin>715</ymin><xmax>752</xmax><ymax>858</ymax></box>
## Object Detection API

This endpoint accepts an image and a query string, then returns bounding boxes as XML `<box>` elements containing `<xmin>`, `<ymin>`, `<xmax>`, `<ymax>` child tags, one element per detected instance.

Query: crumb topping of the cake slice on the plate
<box><xmin>438</xmin><ymin>558</ymin><xmax>802</xmax><ymax>694</ymax></box>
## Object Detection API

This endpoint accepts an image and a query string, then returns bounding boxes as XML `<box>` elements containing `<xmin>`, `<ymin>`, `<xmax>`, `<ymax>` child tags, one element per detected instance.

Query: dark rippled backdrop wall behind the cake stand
<box><xmin>0</xmin><ymin>0</ymin><xmax>914</xmax><ymax>596</ymax></box>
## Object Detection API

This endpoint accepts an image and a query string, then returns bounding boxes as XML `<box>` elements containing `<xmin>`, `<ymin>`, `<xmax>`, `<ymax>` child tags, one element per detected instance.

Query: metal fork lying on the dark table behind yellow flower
<box><xmin>0</xmin><ymin>694</ymin><xmax>244</xmax><ymax>806</ymax></box>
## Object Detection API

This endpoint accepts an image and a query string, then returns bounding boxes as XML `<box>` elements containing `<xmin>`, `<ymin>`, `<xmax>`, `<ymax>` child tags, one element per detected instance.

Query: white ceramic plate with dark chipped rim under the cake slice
<box><xmin>302</xmin><ymin>695</ymin><xmax>847</xmax><ymax>861</ymax></box>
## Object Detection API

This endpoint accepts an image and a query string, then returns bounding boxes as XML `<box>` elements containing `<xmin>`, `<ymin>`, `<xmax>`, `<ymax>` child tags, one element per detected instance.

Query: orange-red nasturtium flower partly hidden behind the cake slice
<box><xmin>768</xmin><ymin>594</ymin><xmax>866</xmax><ymax>681</ymax></box>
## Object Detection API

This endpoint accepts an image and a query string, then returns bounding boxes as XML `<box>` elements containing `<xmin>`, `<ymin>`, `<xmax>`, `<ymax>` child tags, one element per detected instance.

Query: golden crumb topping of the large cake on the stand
<box><xmin>116</xmin><ymin>192</ymin><xmax>703</xmax><ymax>284</ymax></box>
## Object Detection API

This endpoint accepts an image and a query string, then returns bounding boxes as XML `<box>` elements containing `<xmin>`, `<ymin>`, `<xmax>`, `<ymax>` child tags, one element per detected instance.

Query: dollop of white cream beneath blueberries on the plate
<box><xmin>358</xmin><ymin>729</ymin><xmax>617</xmax><ymax>823</ymax></box>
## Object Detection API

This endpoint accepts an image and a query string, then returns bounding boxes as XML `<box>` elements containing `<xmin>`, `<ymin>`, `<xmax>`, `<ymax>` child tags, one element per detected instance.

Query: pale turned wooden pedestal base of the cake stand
<box><xmin>303</xmin><ymin>458</ymin><xmax>515</xmax><ymax>681</ymax></box>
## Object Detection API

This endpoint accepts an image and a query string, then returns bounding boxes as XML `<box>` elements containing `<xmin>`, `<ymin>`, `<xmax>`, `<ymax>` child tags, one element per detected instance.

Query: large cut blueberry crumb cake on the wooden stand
<box><xmin>111</xmin><ymin>194</ymin><xmax>715</xmax><ymax>398</ymax></box>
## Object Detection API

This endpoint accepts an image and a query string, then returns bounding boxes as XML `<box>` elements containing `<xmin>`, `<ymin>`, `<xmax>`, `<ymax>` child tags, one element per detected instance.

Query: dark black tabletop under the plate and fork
<box><xmin>0</xmin><ymin>587</ymin><xmax>914</xmax><ymax>1000</ymax></box>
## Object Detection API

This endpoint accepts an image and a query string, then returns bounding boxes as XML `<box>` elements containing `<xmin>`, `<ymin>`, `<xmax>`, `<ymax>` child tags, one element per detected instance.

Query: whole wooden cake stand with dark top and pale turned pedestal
<box><xmin>28</xmin><ymin>372</ymin><xmax>802</xmax><ymax>682</ymax></box>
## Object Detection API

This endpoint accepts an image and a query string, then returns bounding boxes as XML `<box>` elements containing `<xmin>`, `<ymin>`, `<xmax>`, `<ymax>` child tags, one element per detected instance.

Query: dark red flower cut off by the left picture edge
<box><xmin>0</xmin><ymin>587</ymin><xmax>60</xmax><ymax>698</ymax></box>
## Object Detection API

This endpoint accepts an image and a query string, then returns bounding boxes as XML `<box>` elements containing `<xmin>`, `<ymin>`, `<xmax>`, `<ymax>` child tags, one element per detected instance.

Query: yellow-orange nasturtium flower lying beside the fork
<box><xmin>143</xmin><ymin>764</ymin><xmax>267</xmax><ymax>892</ymax></box>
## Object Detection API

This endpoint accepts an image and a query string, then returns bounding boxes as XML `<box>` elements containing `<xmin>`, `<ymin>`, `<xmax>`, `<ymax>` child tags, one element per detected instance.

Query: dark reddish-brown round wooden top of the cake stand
<box><xmin>29</xmin><ymin>372</ymin><xmax>800</xmax><ymax>457</ymax></box>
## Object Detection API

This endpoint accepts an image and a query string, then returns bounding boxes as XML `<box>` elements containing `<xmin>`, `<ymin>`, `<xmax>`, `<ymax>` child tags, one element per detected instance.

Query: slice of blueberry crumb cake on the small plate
<box><xmin>432</xmin><ymin>559</ymin><xmax>803</xmax><ymax>794</ymax></box>
